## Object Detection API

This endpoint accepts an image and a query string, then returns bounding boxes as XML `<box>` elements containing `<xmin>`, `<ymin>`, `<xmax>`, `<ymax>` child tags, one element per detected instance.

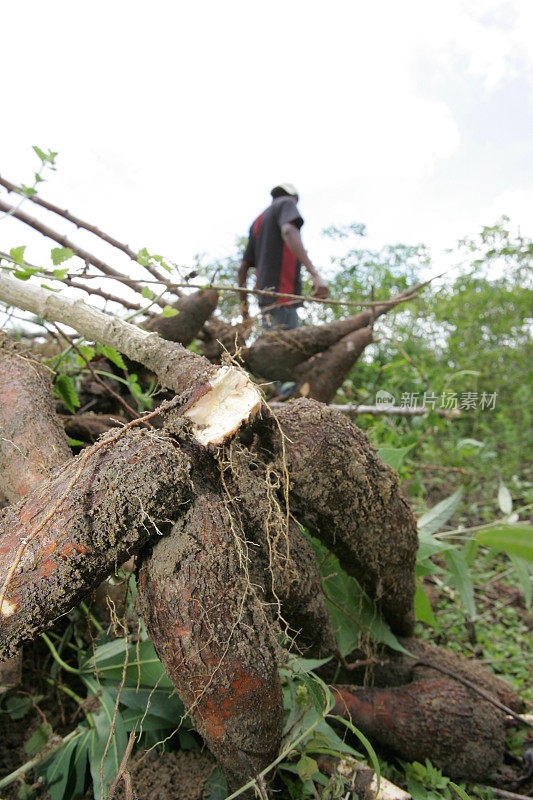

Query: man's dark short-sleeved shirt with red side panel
<box><xmin>243</xmin><ymin>196</ymin><xmax>304</xmax><ymax>308</ymax></box>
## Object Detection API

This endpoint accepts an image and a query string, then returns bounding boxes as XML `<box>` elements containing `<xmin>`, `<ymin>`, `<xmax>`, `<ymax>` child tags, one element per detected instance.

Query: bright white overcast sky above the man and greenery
<box><xmin>0</xmin><ymin>0</ymin><xmax>533</xmax><ymax>282</ymax></box>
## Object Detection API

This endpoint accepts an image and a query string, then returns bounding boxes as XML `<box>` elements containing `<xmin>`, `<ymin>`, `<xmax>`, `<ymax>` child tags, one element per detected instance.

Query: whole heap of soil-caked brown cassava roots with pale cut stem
<box><xmin>0</xmin><ymin>183</ymin><xmax>520</xmax><ymax>800</ymax></box>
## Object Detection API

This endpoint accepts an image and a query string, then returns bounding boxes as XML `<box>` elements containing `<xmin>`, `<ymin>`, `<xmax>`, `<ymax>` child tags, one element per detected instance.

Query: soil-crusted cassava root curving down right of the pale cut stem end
<box><xmin>273</xmin><ymin>400</ymin><xmax>418</xmax><ymax>635</ymax></box>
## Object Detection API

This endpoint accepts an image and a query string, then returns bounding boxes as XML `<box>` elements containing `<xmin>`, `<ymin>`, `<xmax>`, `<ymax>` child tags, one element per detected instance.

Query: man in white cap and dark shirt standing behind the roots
<box><xmin>238</xmin><ymin>183</ymin><xmax>328</xmax><ymax>330</ymax></box>
